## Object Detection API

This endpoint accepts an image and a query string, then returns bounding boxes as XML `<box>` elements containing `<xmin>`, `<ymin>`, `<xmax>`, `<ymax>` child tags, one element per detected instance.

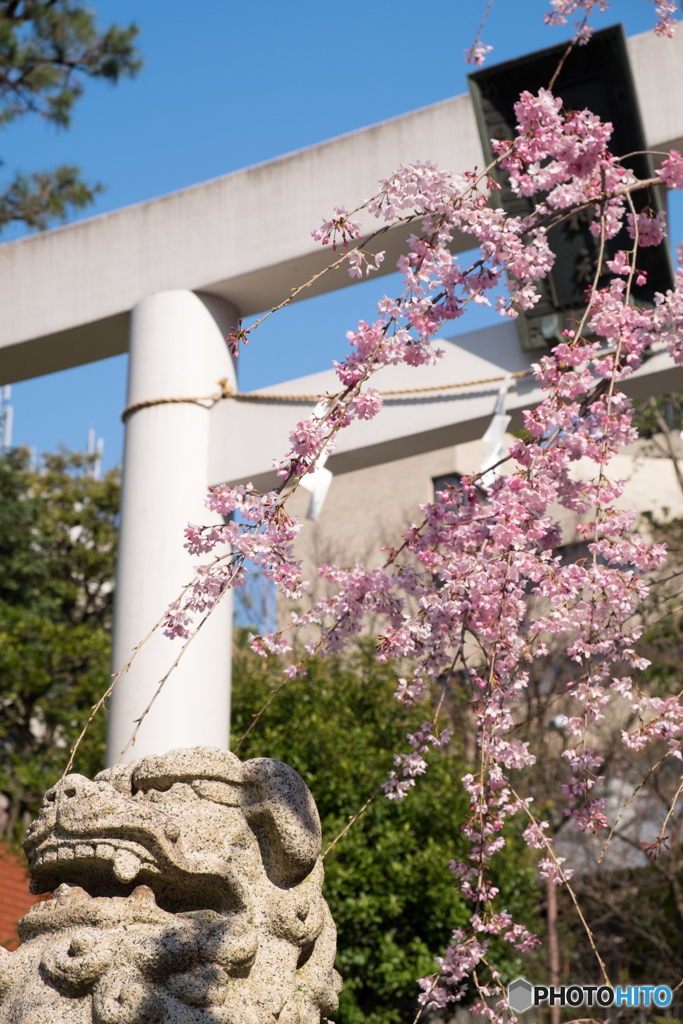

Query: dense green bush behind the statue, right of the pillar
<box><xmin>232</xmin><ymin>634</ymin><xmax>539</xmax><ymax>1024</ymax></box>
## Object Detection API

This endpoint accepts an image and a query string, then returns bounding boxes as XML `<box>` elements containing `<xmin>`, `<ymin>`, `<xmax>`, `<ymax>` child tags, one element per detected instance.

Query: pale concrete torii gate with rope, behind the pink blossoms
<box><xmin>0</xmin><ymin>33</ymin><xmax>683</xmax><ymax>762</ymax></box>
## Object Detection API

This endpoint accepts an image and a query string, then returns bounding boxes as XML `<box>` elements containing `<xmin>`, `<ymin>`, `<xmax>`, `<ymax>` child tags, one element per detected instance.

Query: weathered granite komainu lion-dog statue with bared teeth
<box><xmin>0</xmin><ymin>746</ymin><xmax>341</xmax><ymax>1024</ymax></box>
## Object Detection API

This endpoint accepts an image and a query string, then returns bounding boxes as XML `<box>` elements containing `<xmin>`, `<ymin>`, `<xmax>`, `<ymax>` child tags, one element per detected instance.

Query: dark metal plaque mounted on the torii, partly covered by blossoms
<box><xmin>468</xmin><ymin>25</ymin><xmax>674</xmax><ymax>350</ymax></box>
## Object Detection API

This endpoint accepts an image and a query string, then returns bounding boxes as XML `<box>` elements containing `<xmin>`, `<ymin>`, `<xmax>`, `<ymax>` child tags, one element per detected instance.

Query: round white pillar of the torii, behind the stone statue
<box><xmin>106</xmin><ymin>290</ymin><xmax>237</xmax><ymax>765</ymax></box>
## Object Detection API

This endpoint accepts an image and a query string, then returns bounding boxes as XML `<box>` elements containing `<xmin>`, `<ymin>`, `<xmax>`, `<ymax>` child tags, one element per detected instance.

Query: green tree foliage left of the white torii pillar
<box><xmin>0</xmin><ymin>449</ymin><xmax>119</xmax><ymax>842</ymax></box>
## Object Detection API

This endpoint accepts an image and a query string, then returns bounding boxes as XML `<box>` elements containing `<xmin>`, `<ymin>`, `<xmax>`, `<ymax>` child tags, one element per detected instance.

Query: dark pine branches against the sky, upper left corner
<box><xmin>0</xmin><ymin>0</ymin><xmax>141</xmax><ymax>230</ymax></box>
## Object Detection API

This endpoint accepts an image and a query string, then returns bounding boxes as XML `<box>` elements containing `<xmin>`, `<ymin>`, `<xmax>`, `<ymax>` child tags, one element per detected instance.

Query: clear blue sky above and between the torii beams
<box><xmin>0</xmin><ymin>0</ymin><xmax>683</xmax><ymax>466</ymax></box>
